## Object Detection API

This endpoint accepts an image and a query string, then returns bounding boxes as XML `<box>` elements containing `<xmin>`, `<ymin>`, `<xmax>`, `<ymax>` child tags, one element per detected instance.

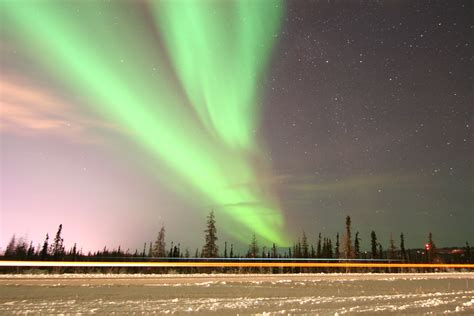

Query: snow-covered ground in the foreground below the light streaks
<box><xmin>0</xmin><ymin>273</ymin><xmax>474</xmax><ymax>315</ymax></box>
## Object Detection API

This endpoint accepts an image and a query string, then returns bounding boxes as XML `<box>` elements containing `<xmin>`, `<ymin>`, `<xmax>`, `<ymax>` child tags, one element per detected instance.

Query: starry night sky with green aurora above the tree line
<box><xmin>0</xmin><ymin>1</ymin><xmax>474</xmax><ymax>250</ymax></box>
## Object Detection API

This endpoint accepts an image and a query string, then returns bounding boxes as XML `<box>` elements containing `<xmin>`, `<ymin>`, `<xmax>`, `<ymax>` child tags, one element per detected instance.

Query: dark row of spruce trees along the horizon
<box><xmin>3</xmin><ymin>211</ymin><xmax>473</xmax><ymax>263</ymax></box>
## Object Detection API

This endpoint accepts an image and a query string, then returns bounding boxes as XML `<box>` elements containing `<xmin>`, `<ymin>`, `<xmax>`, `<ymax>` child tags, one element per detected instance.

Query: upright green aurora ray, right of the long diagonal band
<box><xmin>154</xmin><ymin>0</ymin><xmax>282</xmax><ymax>149</ymax></box>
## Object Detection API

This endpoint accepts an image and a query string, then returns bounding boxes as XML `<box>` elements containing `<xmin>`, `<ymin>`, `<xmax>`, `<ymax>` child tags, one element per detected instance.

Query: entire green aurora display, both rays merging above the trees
<box><xmin>0</xmin><ymin>0</ymin><xmax>288</xmax><ymax>245</ymax></box>
